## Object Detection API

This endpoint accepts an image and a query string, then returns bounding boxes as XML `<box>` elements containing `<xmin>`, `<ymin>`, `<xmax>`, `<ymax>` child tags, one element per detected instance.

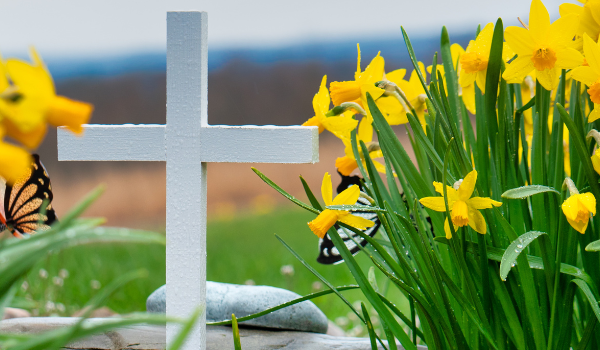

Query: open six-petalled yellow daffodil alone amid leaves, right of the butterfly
<box><xmin>419</xmin><ymin>170</ymin><xmax>502</xmax><ymax>239</ymax></box>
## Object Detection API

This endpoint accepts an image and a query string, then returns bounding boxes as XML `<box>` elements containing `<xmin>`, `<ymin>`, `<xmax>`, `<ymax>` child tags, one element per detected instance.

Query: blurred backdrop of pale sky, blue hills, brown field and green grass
<box><xmin>0</xmin><ymin>0</ymin><xmax>575</xmax><ymax>328</ymax></box>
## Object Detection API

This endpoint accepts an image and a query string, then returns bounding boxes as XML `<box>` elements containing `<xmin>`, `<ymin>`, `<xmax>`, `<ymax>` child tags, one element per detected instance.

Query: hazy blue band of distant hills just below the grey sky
<box><xmin>45</xmin><ymin>33</ymin><xmax>472</xmax><ymax>82</ymax></box>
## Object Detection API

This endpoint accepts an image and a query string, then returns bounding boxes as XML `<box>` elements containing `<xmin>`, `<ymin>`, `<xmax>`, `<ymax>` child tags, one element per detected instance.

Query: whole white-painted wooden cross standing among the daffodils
<box><xmin>58</xmin><ymin>12</ymin><xmax>319</xmax><ymax>350</ymax></box>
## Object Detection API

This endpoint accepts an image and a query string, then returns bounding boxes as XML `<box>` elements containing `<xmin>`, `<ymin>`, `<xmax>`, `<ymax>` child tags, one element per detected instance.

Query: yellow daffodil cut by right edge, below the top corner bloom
<box><xmin>571</xmin><ymin>34</ymin><xmax>600</xmax><ymax>123</ymax></box>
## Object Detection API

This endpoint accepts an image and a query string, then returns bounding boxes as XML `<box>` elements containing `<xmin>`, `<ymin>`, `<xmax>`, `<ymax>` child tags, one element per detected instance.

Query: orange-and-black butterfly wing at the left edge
<box><xmin>4</xmin><ymin>154</ymin><xmax>56</xmax><ymax>237</ymax></box>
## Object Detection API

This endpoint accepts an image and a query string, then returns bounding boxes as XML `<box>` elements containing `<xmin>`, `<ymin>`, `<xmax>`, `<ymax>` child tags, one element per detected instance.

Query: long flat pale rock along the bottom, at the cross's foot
<box><xmin>0</xmin><ymin>317</ymin><xmax>427</xmax><ymax>350</ymax></box>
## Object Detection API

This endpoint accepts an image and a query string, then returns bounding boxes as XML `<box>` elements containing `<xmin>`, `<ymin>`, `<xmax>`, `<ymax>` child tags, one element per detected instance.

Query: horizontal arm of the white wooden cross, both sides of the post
<box><xmin>57</xmin><ymin>125</ymin><xmax>319</xmax><ymax>163</ymax></box>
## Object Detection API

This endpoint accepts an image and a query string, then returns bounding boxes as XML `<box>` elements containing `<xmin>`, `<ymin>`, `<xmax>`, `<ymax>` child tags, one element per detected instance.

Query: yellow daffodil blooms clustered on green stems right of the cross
<box><xmin>304</xmin><ymin>0</ymin><xmax>600</xmax><ymax>236</ymax></box>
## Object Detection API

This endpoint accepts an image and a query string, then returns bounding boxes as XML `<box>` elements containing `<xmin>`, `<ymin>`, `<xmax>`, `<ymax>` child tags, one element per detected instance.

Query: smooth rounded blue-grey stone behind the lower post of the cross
<box><xmin>146</xmin><ymin>281</ymin><xmax>328</xmax><ymax>333</ymax></box>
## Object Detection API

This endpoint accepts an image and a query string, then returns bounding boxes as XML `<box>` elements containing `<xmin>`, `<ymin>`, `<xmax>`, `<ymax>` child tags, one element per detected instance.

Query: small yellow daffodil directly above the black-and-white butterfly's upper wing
<box><xmin>335</xmin><ymin>118</ymin><xmax>385</xmax><ymax>176</ymax></box>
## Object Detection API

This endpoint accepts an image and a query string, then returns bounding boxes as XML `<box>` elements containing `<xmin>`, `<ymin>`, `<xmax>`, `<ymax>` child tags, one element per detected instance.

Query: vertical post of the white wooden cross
<box><xmin>165</xmin><ymin>12</ymin><xmax>208</xmax><ymax>349</ymax></box>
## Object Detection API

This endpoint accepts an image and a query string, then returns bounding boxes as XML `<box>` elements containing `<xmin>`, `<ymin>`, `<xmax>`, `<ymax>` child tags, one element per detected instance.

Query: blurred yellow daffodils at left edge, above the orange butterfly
<box><xmin>0</xmin><ymin>48</ymin><xmax>93</xmax><ymax>183</ymax></box>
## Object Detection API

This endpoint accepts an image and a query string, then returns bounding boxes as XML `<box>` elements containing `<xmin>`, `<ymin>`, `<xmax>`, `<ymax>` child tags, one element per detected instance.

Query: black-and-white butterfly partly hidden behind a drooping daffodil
<box><xmin>317</xmin><ymin>174</ymin><xmax>381</xmax><ymax>265</ymax></box>
